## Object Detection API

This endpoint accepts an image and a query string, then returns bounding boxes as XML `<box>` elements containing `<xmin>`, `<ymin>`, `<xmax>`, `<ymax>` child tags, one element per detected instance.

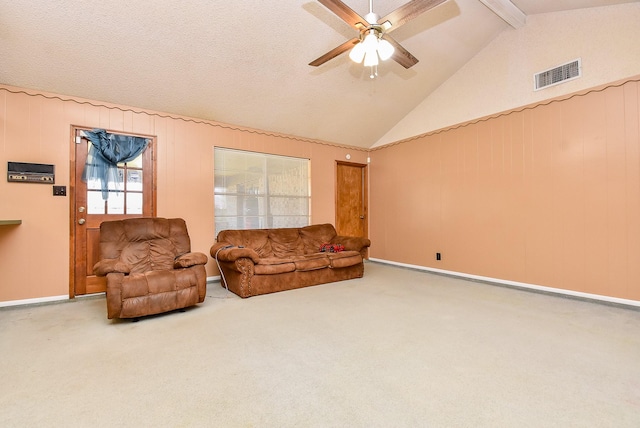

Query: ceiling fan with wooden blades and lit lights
<box><xmin>309</xmin><ymin>0</ymin><xmax>446</xmax><ymax>72</ymax></box>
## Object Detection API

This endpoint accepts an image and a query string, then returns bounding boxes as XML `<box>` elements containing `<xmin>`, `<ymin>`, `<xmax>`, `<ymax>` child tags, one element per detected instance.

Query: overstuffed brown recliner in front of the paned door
<box><xmin>93</xmin><ymin>218</ymin><xmax>208</xmax><ymax>319</ymax></box>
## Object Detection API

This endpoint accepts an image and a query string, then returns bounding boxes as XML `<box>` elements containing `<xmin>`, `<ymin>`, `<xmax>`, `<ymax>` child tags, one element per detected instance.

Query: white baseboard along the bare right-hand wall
<box><xmin>369</xmin><ymin>258</ymin><xmax>640</xmax><ymax>307</ymax></box>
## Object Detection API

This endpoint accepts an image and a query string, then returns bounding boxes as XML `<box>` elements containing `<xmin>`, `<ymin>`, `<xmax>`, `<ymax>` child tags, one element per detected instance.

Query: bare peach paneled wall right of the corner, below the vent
<box><xmin>370</xmin><ymin>78</ymin><xmax>640</xmax><ymax>300</ymax></box>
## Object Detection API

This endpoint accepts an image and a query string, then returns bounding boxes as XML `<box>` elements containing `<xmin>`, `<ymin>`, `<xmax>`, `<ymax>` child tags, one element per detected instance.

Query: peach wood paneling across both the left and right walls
<box><xmin>0</xmin><ymin>79</ymin><xmax>640</xmax><ymax>302</ymax></box>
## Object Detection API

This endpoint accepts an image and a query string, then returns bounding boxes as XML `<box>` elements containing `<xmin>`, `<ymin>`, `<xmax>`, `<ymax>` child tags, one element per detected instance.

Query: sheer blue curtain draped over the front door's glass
<box><xmin>82</xmin><ymin>129</ymin><xmax>149</xmax><ymax>201</ymax></box>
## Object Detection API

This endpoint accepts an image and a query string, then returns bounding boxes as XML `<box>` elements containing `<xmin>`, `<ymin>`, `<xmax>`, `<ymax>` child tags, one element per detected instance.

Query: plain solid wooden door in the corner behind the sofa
<box><xmin>336</xmin><ymin>162</ymin><xmax>368</xmax><ymax>238</ymax></box>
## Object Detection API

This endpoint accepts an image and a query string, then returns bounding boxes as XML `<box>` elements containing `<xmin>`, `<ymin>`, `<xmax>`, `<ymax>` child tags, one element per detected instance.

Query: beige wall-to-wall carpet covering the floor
<box><xmin>0</xmin><ymin>263</ymin><xmax>640</xmax><ymax>428</ymax></box>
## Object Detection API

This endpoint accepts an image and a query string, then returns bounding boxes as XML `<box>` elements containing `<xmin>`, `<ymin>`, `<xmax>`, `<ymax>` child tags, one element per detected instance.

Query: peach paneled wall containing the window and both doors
<box><xmin>0</xmin><ymin>85</ymin><xmax>367</xmax><ymax>302</ymax></box>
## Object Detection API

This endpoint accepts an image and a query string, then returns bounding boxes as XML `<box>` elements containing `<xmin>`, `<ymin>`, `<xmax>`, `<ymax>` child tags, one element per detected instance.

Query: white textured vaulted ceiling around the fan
<box><xmin>0</xmin><ymin>0</ymin><xmax>633</xmax><ymax>147</ymax></box>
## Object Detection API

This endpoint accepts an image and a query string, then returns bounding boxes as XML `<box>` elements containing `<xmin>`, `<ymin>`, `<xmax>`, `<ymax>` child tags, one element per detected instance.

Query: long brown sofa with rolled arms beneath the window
<box><xmin>210</xmin><ymin>224</ymin><xmax>371</xmax><ymax>297</ymax></box>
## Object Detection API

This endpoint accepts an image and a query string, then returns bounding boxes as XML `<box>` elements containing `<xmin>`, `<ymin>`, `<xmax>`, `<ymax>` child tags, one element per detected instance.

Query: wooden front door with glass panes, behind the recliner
<box><xmin>69</xmin><ymin>127</ymin><xmax>156</xmax><ymax>298</ymax></box>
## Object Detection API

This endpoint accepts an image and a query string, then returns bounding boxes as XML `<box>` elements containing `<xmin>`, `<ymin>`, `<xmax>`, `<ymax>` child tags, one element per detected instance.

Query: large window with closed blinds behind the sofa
<box><xmin>214</xmin><ymin>147</ymin><xmax>311</xmax><ymax>235</ymax></box>
